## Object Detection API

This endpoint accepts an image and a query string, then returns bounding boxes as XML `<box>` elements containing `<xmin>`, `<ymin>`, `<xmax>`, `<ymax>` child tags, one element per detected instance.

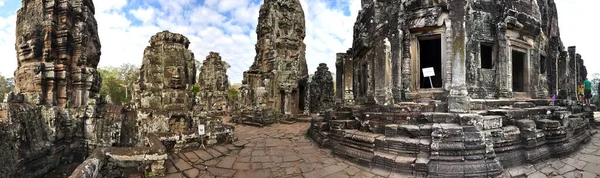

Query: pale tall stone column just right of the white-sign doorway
<box><xmin>445</xmin><ymin>1</ymin><xmax>470</xmax><ymax>113</ymax></box>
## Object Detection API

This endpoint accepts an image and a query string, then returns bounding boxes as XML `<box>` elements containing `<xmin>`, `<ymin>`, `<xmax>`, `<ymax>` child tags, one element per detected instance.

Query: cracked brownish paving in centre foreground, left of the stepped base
<box><xmin>165</xmin><ymin>120</ymin><xmax>392</xmax><ymax>178</ymax></box>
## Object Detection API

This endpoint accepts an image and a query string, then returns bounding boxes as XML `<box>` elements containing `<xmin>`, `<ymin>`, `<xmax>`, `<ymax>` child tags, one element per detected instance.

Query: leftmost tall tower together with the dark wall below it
<box><xmin>0</xmin><ymin>0</ymin><xmax>105</xmax><ymax>177</ymax></box>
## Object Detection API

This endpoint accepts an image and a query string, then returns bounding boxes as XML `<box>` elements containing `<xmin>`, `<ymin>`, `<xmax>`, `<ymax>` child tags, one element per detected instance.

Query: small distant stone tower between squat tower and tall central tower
<box><xmin>198</xmin><ymin>52</ymin><xmax>229</xmax><ymax>110</ymax></box>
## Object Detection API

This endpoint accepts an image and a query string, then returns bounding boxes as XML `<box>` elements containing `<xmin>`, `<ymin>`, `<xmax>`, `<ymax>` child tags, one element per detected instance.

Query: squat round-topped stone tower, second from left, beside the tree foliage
<box><xmin>137</xmin><ymin>31</ymin><xmax>196</xmax><ymax>111</ymax></box>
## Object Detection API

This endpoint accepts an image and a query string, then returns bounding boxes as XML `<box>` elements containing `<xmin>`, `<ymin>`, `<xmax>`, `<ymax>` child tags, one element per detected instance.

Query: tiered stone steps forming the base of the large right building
<box><xmin>308</xmin><ymin>99</ymin><xmax>595</xmax><ymax>177</ymax></box>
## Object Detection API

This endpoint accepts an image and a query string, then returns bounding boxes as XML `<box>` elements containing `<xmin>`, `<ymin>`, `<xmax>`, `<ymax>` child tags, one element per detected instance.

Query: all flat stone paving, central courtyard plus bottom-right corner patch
<box><xmin>156</xmin><ymin>117</ymin><xmax>600</xmax><ymax>178</ymax></box>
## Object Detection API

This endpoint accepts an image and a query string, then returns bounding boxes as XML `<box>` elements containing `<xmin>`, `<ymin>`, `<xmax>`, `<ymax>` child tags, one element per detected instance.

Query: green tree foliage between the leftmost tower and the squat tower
<box><xmin>98</xmin><ymin>64</ymin><xmax>140</xmax><ymax>104</ymax></box>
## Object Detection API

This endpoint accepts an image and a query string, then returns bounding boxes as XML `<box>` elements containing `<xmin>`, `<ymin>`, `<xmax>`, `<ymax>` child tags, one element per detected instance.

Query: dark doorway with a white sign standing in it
<box><xmin>419</xmin><ymin>36</ymin><xmax>442</xmax><ymax>88</ymax></box>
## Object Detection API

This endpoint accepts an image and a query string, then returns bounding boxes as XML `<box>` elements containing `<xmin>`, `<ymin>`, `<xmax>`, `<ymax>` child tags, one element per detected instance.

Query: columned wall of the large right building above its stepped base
<box><xmin>338</xmin><ymin>0</ymin><xmax>585</xmax><ymax>108</ymax></box>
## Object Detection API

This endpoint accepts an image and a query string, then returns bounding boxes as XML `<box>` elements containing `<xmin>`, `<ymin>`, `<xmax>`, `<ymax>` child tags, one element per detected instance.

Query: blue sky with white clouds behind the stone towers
<box><xmin>0</xmin><ymin>0</ymin><xmax>600</xmax><ymax>83</ymax></box>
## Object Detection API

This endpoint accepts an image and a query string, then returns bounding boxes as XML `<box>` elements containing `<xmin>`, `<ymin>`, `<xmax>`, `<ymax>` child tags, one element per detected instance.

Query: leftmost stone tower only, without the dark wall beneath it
<box><xmin>14</xmin><ymin>0</ymin><xmax>102</xmax><ymax>108</ymax></box>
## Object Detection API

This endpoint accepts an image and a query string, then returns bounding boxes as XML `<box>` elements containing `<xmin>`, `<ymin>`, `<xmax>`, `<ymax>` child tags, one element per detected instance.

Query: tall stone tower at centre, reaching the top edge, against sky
<box><xmin>241</xmin><ymin>0</ymin><xmax>308</xmax><ymax>114</ymax></box>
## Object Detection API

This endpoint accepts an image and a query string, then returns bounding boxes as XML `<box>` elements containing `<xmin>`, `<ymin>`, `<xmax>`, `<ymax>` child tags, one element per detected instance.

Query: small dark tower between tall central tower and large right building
<box><xmin>308</xmin><ymin>63</ymin><xmax>333</xmax><ymax>113</ymax></box>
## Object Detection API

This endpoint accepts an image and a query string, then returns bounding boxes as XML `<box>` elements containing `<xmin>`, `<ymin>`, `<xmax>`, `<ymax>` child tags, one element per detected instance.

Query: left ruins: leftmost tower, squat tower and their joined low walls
<box><xmin>0</xmin><ymin>0</ymin><xmax>233</xmax><ymax>177</ymax></box>
